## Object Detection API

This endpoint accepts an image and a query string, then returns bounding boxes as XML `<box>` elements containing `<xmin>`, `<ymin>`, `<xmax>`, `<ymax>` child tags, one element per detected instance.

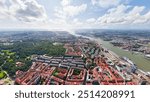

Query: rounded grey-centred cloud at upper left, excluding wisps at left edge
<box><xmin>10</xmin><ymin>0</ymin><xmax>47</xmax><ymax>22</ymax></box>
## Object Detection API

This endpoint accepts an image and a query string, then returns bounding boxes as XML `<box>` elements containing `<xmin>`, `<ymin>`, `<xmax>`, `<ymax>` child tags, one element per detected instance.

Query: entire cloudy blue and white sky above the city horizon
<box><xmin>0</xmin><ymin>0</ymin><xmax>150</xmax><ymax>29</ymax></box>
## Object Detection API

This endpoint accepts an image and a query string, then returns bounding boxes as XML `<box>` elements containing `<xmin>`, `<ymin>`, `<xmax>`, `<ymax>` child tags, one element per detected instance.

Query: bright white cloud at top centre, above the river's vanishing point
<box><xmin>51</xmin><ymin>0</ymin><xmax>87</xmax><ymax>29</ymax></box>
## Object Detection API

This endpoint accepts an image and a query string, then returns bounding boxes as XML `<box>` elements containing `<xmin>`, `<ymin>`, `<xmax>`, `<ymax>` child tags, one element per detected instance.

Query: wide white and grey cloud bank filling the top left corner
<box><xmin>0</xmin><ymin>0</ymin><xmax>47</xmax><ymax>22</ymax></box>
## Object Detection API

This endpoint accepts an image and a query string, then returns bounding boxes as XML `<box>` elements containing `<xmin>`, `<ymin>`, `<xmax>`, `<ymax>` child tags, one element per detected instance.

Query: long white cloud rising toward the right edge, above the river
<box><xmin>97</xmin><ymin>5</ymin><xmax>150</xmax><ymax>25</ymax></box>
